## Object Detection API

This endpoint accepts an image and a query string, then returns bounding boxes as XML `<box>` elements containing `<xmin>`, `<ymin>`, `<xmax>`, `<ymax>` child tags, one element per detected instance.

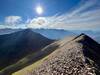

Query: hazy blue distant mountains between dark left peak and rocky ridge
<box><xmin>33</xmin><ymin>29</ymin><xmax>76</xmax><ymax>39</ymax></box>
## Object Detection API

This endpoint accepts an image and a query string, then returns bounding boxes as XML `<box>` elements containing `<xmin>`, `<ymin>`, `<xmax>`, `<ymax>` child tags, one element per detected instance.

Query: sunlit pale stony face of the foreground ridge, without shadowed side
<box><xmin>26</xmin><ymin>35</ymin><xmax>100</xmax><ymax>75</ymax></box>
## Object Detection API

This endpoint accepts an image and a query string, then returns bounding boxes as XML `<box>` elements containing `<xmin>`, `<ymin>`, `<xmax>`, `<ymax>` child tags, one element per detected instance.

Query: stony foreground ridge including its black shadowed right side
<box><xmin>26</xmin><ymin>34</ymin><xmax>100</xmax><ymax>75</ymax></box>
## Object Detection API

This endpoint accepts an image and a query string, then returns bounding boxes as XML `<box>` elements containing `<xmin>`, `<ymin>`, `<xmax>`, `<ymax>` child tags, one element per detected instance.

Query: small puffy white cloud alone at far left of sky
<box><xmin>5</xmin><ymin>16</ymin><xmax>22</xmax><ymax>25</ymax></box>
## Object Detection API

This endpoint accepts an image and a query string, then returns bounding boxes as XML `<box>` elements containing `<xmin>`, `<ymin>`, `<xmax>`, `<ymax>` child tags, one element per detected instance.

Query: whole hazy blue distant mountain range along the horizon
<box><xmin>0</xmin><ymin>29</ymin><xmax>100</xmax><ymax>43</ymax></box>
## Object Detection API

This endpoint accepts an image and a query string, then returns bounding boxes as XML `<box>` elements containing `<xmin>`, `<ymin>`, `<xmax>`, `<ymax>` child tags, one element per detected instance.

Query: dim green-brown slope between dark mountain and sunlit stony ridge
<box><xmin>0</xmin><ymin>40</ymin><xmax>58</xmax><ymax>75</ymax></box>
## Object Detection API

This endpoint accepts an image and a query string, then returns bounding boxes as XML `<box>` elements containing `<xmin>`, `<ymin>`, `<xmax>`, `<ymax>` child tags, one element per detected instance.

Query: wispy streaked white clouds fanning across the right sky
<box><xmin>26</xmin><ymin>0</ymin><xmax>100</xmax><ymax>30</ymax></box>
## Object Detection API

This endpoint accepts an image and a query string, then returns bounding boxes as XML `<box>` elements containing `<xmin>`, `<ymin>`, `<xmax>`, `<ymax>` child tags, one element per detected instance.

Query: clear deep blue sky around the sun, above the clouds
<box><xmin>0</xmin><ymin>0</ymin><xmax>80</xmax><ymax>21</ymax></box>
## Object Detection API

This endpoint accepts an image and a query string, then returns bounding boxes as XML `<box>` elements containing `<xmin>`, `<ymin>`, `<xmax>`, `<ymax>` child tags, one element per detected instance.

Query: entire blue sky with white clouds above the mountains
<box><xmin>0</xmin><ymin>0</ymin><xmax>100</xmax><ymax>30</ymax></box>
